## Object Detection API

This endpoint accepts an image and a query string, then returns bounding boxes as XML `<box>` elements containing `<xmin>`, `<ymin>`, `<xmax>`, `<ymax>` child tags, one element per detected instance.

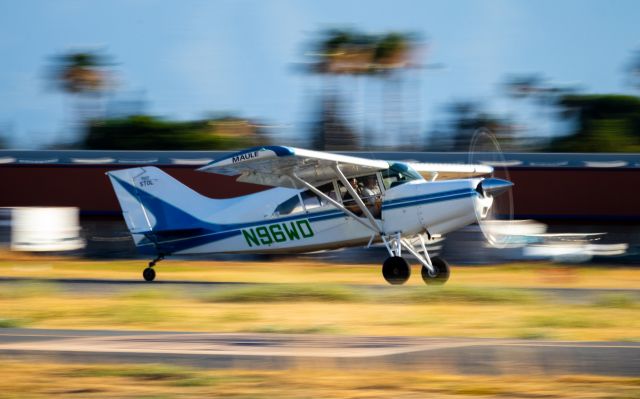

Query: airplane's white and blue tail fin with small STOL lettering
<box><xmin>107</xmin><ymin>166</ymin><xmax>212</xmax><ymax>234</ymax></box>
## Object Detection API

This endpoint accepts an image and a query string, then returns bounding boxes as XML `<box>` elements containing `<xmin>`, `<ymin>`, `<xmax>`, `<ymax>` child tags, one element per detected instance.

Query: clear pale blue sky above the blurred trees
<box><xmin>0</xmin><ymin>0</ymin><xmax>640</xmax><ymax>148</ymax></box>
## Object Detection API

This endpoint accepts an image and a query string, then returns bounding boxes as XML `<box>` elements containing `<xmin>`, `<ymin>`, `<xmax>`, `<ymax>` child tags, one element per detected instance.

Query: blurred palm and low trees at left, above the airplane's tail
<box><xmin>49</xmin><ymin>52</ymin><xmax>268</xmax><ymax>150</ymax></box>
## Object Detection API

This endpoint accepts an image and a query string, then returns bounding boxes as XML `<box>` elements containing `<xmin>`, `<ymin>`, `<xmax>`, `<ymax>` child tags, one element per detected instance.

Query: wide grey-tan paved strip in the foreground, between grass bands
<box><xmin>0</xmin><ymin>329</ymin><xmax>640</xmax><ymax>376</ymax></box>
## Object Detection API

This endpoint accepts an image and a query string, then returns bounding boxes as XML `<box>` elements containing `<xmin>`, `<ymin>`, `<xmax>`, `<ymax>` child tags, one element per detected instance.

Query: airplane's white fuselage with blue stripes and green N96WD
<box><xmin>133</xmin><ymin>176</ymin><xmax>484</xmax><ymax>255</ymax></box>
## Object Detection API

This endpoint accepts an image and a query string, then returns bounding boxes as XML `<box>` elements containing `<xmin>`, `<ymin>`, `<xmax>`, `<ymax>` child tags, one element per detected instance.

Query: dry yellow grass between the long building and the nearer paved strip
<box><xmin>0</xmin><ymin>258</ymin><xmax>640</xmax><ymax>341</ymax></box>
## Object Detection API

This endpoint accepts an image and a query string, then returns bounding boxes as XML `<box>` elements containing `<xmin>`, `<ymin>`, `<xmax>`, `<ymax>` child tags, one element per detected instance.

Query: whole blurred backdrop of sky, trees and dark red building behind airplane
<box><xmin>0</xmin><ymin>0</ymin><xmax>640</xmax><ymax>263</ymax></box>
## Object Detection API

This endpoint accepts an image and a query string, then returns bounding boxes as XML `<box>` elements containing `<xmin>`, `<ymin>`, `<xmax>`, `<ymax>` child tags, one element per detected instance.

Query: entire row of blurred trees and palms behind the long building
<box><xmin>41</xmin><ymin>38</ymin><xmax>640</xmax><ymax>152</ymax></box>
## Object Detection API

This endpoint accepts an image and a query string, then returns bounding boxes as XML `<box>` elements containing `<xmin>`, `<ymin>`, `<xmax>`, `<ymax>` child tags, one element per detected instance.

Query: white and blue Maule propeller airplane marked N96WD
<box><xmin>107</xmin><ymin>146</ymin><xmax>513</xmax><ymax>285</ymax></box>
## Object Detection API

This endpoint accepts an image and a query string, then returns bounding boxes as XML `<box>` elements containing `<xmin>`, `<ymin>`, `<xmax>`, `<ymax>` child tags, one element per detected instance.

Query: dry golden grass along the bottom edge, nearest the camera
<box><xmin>0</xmin><ymin>359</ymin><xmax>640</xmax><ymax>399</ymax></box>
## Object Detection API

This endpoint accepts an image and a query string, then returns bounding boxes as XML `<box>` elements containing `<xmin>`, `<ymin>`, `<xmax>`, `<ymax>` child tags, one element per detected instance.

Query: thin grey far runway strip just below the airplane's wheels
<box><xmin>0</xmin><ymin>277</ymin><xmax>640</xmax><ymax>303</ymax></box>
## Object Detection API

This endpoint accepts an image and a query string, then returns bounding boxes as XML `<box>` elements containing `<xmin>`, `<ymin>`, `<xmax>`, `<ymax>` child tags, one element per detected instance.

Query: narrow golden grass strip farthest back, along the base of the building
<box><xmin>0</xmin><ymin>254</ymin><xmax>640</xmax><ymax>289</ymax></box>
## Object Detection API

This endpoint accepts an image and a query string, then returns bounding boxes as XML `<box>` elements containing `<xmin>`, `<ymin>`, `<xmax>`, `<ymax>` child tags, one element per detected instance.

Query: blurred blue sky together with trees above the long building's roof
<box><xmin>0</xmin><ymin>0</ymin><xmax>640</xmax><ymax>152</ymax></box>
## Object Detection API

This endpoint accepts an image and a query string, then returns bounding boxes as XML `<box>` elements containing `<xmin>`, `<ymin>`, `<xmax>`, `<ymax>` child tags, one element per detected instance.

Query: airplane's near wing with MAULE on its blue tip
<box><xmin>198</xmin><ymin>146</ymin><xmax>389</xmax><ymax>188</ymax></box>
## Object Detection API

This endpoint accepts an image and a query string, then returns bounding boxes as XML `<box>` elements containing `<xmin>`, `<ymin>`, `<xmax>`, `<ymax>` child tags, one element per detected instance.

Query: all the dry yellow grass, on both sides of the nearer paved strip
<box><xmin>0</xmin><ymin>254</ymin><xmax>640</xmax><ymax>399</ymax></box>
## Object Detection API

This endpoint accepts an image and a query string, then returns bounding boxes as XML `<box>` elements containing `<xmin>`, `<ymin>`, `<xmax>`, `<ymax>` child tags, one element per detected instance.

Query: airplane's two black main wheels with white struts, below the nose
<box><xmin>382</xmin><ymin>234</ymin><xmax>450</xmax><ymax>285</ymax></box>
